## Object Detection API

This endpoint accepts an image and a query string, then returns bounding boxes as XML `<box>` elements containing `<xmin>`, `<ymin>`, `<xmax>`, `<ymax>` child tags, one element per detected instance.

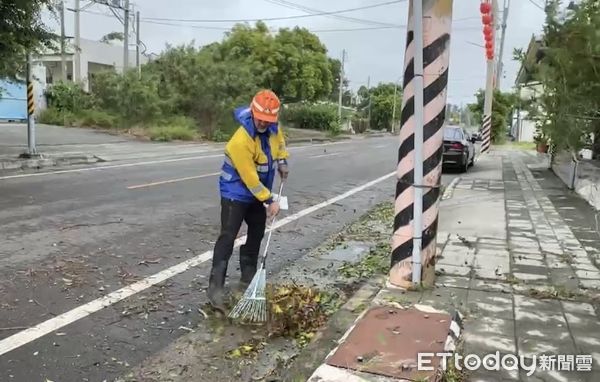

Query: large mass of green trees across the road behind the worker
<box><xmin>35</xmin><ymin>22</ymin><xmax>340</xmax><ymax>141</ymax></box>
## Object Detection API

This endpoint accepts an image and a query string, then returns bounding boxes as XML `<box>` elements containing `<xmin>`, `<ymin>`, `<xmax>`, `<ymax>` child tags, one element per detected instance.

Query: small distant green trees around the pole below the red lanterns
<box><xmin>469</xmin><ymin>89</ymin><xmax>519</xmax><ymax>143</ymax></box>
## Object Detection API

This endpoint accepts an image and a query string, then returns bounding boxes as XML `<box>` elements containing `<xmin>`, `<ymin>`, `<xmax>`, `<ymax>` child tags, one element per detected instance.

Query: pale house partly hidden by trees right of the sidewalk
<box><xmin>511</xmin><ymin>35</ymin><xmax>544</xmax><ymax>142</ymax></box>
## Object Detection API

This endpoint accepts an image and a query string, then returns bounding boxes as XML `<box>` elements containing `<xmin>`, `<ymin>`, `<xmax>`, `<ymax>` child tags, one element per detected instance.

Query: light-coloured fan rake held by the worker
<box><xmin>229</xmin><ymin>180</ymin><xmax>283</xmax><ymax>323</ymax></box>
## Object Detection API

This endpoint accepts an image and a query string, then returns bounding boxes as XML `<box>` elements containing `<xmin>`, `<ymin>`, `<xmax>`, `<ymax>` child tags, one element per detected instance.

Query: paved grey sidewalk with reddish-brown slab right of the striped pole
<box><xmin>309</xmin><ymin>151</ymin><xmax>600</xmax><ymax>382</ymax></box>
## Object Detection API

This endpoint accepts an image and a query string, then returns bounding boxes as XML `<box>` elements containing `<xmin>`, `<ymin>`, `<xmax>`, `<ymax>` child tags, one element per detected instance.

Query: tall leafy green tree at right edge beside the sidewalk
<box><xmin>516</xmin><ymin>0</ymin><xmax>600</xmax><ymax>151</ymax></box>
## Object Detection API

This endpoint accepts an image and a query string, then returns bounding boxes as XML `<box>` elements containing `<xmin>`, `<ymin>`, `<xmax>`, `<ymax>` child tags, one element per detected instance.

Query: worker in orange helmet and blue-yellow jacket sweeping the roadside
<box><xmin>207</xmin><ymin>90</ymin><xmax>289</xmax><ymax>313</ymax></box>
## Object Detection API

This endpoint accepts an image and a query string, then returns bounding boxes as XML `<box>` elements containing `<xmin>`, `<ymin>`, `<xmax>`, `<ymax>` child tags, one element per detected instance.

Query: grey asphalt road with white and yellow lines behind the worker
<box><xmin>0</xmin><ymin>137</ymin><xmax>458</xmax><ymax>382</ymax></box>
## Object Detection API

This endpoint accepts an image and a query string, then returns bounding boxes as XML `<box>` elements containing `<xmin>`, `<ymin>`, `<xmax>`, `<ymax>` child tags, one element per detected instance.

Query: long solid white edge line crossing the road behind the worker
<box><xmin>0</xmin><ymin>171</ymin><xmax>396</xmax><ymax>356</ymax></box>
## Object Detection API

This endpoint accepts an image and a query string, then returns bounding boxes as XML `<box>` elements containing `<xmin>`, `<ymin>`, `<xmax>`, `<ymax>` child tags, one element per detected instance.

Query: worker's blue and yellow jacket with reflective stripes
<box><xmin>219</xmin><ymin>107</ymin><xmax>289</xmax><ymax>203</ymax></box>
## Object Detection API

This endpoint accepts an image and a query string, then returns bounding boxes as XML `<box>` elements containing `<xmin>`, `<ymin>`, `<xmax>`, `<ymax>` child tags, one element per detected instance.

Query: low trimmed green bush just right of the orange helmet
<box><xmin>281</xmin><ymin>104</ymin><xmax>341</xmax><ymax>133</ymax></box>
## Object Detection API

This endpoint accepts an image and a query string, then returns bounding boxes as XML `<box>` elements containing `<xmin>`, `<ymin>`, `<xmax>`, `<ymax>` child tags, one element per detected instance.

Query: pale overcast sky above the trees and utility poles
<box><xmin>44</xmin><ymin>0</ymin><xmax>544</xmax><ymax>105</ymax></box>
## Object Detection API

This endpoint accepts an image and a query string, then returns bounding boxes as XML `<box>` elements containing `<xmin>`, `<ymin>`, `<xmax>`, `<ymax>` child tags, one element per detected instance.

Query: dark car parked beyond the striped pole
<box><xmin>442</xmin><ymin>126</ymin><xmax>476</xmax><ymax>172</ymax></box>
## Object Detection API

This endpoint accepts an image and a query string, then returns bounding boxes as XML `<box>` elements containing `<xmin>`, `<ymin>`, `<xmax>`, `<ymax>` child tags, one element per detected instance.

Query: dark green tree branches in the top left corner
<box><xmin>0</xmin><ymin>0</ymin><xmax>55</xmax><ymax>80</ymax></box>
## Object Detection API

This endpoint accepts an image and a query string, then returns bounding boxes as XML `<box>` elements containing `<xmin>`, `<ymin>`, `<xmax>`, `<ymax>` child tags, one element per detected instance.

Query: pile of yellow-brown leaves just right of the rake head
<box><xmin>267</xmin><ymin>284</ymin><xmax>337</xmax><ymax>344</ymax></box>
